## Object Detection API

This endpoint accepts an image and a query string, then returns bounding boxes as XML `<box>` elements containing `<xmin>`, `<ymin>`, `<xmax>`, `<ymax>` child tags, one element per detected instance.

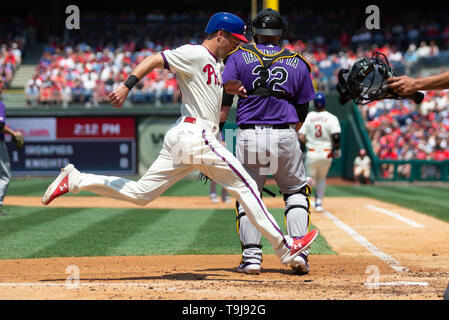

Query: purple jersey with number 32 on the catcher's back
<box><xmin>223</xmin><ymin>44</ymin><xmax>315</xmax><ymax>125</ymax></box>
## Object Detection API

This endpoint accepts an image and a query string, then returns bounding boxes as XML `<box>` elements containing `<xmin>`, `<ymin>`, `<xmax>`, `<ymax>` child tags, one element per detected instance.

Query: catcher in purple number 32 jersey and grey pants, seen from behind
<box><xmin>220</xmin><ymin>9</ymin><xmax>315</xmax><ymax>274</ymax></box>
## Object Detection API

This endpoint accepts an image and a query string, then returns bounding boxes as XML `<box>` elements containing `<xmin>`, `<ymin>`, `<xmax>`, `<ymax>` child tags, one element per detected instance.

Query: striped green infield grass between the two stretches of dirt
<box><xmin>0</xmin><ymin>206</ymin><xmax>335</xmax><ymax>259</ymax></box>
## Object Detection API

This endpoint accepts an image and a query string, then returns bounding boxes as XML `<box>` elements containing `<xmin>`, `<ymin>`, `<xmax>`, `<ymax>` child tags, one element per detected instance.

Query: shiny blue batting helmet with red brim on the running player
<box><xmin>206</xmin><ymin>12</ymin><xmax>248</xmax><ymax>42</ymax></box>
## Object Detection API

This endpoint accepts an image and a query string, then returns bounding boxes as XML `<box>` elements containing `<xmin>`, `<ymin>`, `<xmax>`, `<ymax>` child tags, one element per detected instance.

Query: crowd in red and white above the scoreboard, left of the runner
<box><xmin>25</xmin><ymin>44</ymin><xmax>179</xmax><ymax>107</ymax></box>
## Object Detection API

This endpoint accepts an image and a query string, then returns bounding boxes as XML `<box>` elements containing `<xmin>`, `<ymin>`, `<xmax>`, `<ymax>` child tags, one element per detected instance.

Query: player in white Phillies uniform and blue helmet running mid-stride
<box><xmin>42</xmin><ymin>12</ymin><xmax>318</xmax><ymax>264</ymax></box>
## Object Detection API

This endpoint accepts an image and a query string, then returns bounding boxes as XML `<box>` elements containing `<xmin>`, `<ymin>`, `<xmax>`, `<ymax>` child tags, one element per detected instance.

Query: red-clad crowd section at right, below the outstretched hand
<box><xmin>360</xmin><ymin>90</ymin><xmax>449</xmax><ymax>178</ymax></box>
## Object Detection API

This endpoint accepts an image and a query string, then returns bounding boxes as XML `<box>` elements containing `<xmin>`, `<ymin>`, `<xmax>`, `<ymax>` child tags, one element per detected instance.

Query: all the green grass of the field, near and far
<box><xmin>0</xmin><ymin>177</ymin><xmax>449</xmax><ymax>259</ymax></box>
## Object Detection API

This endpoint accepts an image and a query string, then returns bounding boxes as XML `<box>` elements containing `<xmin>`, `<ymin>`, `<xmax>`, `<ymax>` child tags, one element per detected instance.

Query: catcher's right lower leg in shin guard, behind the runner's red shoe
<box><xmin>284</xmin><ymin>186</ymin><xmax>311</xmax><ymax>274</ymax></box>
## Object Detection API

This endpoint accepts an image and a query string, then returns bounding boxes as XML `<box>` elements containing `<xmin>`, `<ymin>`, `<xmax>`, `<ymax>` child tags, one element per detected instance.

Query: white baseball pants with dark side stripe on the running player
<box><xmin>69</xmin><ymin>117</ymin><xmax>293</xmax><ymax>262</ymax></box>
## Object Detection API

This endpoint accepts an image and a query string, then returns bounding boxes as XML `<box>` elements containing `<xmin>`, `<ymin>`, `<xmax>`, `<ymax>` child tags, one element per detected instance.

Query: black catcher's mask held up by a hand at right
<box><xmin>337</xmin><ymin>51</ymin><xmax>424</xmax><ymax>105</ymax></box>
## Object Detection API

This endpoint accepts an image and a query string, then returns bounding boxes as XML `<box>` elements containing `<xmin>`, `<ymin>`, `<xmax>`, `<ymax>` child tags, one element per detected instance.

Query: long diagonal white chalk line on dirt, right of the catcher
<box><xmin>323</xmin><ymin>210</ymin><xmax>409</xmax><ymax>272</ymax></box>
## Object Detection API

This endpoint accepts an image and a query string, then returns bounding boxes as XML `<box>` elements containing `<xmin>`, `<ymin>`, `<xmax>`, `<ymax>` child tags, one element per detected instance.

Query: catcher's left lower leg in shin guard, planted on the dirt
<box><xmin>235</xmin><ymin>201</ymin><xmax>262</xmax><ymax>274</ymax></box>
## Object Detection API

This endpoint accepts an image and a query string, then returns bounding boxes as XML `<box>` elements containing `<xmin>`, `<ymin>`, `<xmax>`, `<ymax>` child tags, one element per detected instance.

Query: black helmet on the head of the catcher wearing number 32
<box><xmin>248</xmin><ymin>8</ymin><xmax>288</xmax><ymax>43</ymax></box>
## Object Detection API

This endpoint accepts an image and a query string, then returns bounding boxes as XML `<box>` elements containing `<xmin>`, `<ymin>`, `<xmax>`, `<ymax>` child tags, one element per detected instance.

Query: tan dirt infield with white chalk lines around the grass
<box><xmin>0</xmin><ymin>197</ymin><xmax>449</xmax><ymax>300</ymax></box>
